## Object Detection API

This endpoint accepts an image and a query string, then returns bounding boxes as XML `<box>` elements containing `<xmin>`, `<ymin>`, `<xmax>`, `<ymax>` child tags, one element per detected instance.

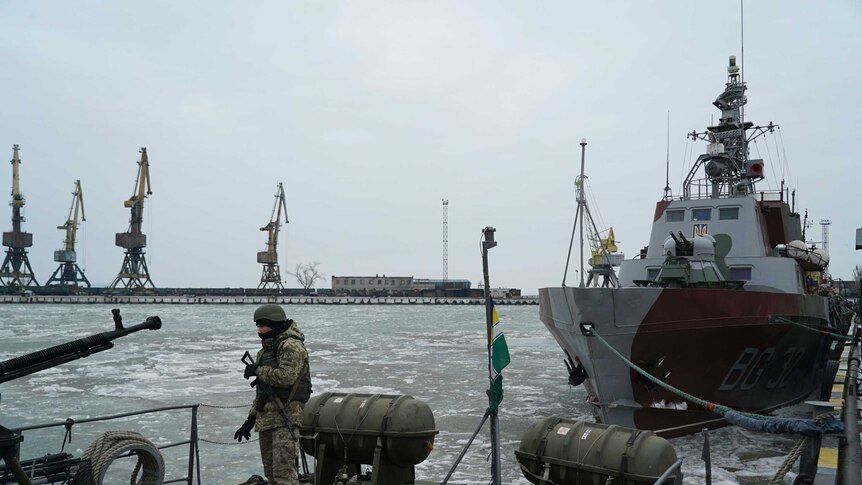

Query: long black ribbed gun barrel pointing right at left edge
<box><xmin>0</xmin><ymin>317</ymin><xmax>162</xmax><ymax>383</ymax></box>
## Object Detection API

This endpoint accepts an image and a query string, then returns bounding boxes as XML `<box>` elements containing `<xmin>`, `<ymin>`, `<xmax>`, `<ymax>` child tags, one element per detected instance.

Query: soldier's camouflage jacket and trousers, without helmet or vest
<box><xmin>249</xmin><ymin>322</ymin><xmax>308</xmax><ymax>485</ymax></box>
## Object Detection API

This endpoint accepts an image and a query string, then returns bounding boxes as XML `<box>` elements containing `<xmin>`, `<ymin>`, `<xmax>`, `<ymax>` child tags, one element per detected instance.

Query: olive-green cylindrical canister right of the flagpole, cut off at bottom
<box><xmin>515</xmin><ymin>418</ymin><xmax>682</xmax><ymax>485</ymax></box>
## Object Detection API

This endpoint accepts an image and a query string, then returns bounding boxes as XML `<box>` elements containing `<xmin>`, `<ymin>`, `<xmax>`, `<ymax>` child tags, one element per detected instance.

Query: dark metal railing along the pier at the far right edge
<box><xmin>836</xmin><ymin>322</ymin><xmax>862</xmax><ymax>485</ymax></box>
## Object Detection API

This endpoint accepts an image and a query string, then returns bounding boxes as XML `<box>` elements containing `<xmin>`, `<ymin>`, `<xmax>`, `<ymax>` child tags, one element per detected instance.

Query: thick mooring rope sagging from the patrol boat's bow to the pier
<box><xmin>581</xmin><ymin>322</ymin><xmax>844</xmax><ymax>436</ymax></box>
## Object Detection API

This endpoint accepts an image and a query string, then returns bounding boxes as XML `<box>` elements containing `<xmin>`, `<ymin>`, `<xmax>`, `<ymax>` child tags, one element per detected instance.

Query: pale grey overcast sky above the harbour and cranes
<box><xmin>0</xmin><ymin>0</ymin><xmax>862</xmax><ymax>294</ymax></box>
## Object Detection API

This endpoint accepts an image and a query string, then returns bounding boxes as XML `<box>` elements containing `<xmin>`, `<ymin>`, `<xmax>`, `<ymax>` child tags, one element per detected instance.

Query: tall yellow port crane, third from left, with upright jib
<box><xmin>109</xmin><ymin>147</ymin><xmax>156</xmax><ymax>290</ymax></box>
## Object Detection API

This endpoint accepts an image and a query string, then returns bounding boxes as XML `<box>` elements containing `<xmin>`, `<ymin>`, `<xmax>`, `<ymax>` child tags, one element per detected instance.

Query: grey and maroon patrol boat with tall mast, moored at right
<box><xmin>539</xmin><ymin>57</ymin><xmax>849</xmax><ymax>436</ymax></box>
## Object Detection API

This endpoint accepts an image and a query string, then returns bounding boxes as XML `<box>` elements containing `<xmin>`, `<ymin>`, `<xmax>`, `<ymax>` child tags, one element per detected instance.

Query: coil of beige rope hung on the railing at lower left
<box><xmin>75</xmin><ymin>431</ymin><xmax>165</xmax><ymax>485</ymax></box>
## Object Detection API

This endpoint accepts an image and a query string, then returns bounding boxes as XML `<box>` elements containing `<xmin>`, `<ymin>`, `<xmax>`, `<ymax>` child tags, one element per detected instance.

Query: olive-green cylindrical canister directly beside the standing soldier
<box><xmin>300</xmin><ymin>392</ymin><xmax>439</xmax><ymax>466</ymax></box>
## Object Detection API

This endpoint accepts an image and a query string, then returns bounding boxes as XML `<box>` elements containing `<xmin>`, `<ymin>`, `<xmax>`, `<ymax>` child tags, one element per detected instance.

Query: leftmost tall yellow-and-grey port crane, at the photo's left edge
<box><xmin>0</xmin><ymin>145</ymin><xmax>39</xmax><ymax>288</ymax></box>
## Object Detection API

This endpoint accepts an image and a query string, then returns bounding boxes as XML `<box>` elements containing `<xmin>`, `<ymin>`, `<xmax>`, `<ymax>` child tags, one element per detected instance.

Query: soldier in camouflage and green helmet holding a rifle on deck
<box><xmin>234</xmin><ymin>305</ymin><xmax>311</xmax><ymax>485</ymax></box>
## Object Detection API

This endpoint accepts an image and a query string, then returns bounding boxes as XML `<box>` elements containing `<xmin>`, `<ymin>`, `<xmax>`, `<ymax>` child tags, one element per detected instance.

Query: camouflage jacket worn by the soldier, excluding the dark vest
<box><xmin>249</xmin><ymin>322</ymin><xmax>308</xmax><ymax>432</ymax></box>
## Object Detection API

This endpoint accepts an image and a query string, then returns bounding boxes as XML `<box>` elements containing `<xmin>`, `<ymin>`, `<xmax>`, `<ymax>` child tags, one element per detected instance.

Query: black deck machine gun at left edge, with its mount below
<box><xmin>0</xmin><ymin>309</ymin><xmax>162</xmax><ymax>485</ymax></box>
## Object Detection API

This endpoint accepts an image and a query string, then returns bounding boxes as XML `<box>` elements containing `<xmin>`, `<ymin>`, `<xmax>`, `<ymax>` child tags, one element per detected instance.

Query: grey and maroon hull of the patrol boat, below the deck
<box><xmin>539</xmin><ymin>287</ymin><xmax>832</xmax><ymax>436</ymax></box>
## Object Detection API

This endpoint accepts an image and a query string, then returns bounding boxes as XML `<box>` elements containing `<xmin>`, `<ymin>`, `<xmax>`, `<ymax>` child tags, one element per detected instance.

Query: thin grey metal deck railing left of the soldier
<box><xmin>11</xmin><ymin>404</ymin><xmax>201</xmax><ymax>485</ymax></box>
